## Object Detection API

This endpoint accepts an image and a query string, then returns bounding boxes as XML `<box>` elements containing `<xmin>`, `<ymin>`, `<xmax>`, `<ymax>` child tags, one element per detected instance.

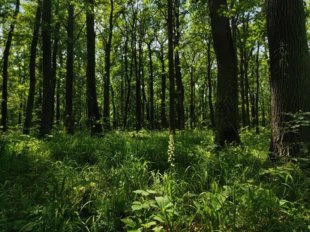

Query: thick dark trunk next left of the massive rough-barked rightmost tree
<box><xmin>209</xmin><ymin>0</ymin><xmax>240</xmax><ymax>145</ymax></box>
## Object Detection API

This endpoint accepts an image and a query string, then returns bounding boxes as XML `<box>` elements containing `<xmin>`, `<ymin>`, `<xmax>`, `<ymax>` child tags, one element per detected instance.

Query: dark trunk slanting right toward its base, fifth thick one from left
<box><xmin>86</xmin><ymin>0</ymin><xmax>102</xmax><ymax>135</ymax></box>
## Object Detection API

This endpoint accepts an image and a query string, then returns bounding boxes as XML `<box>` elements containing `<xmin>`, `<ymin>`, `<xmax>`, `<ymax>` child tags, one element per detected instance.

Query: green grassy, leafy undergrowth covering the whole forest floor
<box><xmin>0</xmin><ymin>130</ymin><xmax>310</xmax><ymax>232</ymax></box>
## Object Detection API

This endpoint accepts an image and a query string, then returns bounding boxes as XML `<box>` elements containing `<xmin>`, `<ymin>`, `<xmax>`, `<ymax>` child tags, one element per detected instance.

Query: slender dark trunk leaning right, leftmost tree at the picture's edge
<box><xmin>1</xmin><ymin>0</ymin><xmax>20</xmax><ymax>131</ymax></box>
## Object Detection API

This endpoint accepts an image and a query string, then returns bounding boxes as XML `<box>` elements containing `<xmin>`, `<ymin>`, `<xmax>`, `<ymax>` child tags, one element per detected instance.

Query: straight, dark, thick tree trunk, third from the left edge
<box><xmin>40</xmin><ymin>0</ymin><xmax>53</xmax><ymax>136</ymax></box>
